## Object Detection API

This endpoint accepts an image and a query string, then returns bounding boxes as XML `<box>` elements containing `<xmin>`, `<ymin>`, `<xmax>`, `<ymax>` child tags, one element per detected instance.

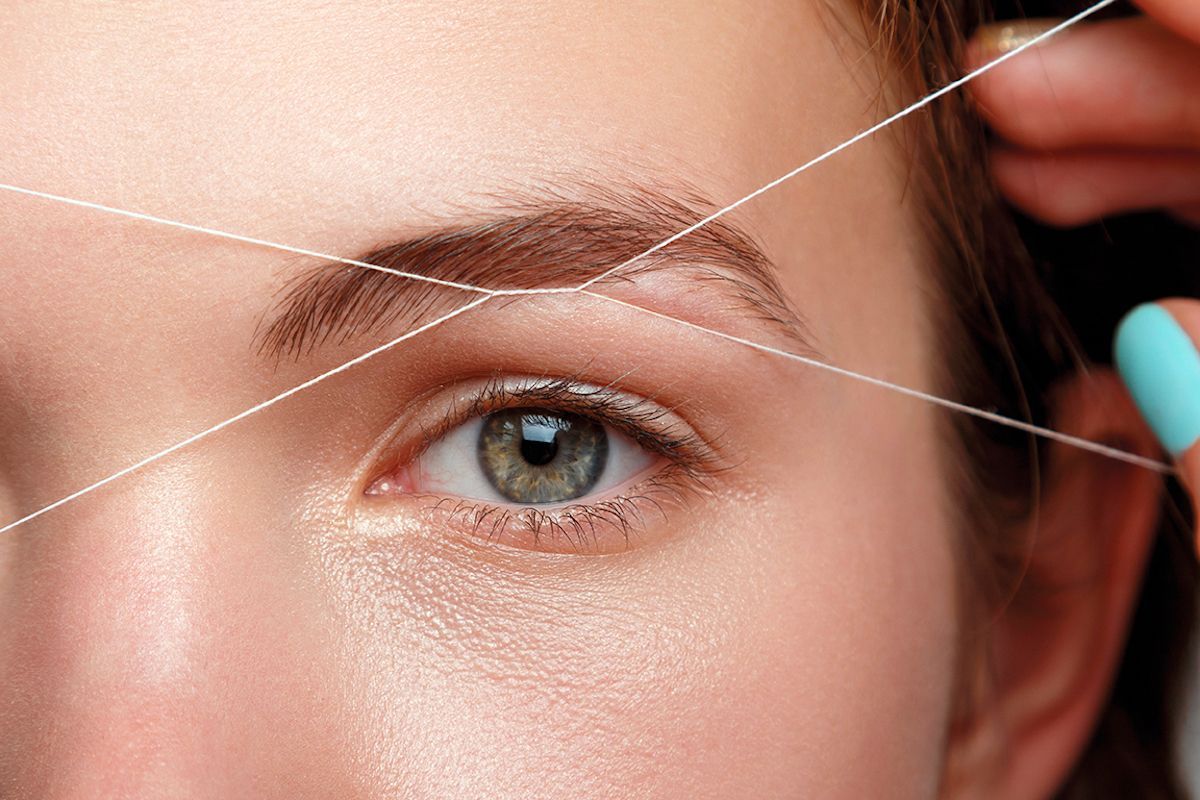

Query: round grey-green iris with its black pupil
<box><xmin>476</xmin><ymin>408</ymin><xmax>608</xmax><ymax>503</ymax></box>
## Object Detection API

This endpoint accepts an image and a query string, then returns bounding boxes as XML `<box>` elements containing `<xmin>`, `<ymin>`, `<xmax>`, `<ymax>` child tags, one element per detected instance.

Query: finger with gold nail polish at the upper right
<box><xmin>968</xmin><ymin>18</ymin><xmax>1200</xmax><ymax>150</ymax></box>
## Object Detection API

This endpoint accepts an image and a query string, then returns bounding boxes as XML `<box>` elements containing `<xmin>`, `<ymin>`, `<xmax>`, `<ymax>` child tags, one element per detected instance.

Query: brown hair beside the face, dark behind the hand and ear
<box><xmin>835</xmin><ymin>0</ymin><xmax>1200</xmax><ymax>800</ymax></box>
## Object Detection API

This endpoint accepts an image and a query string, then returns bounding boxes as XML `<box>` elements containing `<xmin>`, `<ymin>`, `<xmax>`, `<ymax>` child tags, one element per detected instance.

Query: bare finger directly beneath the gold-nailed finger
<box><xmin>991</xmin><ymin>149</ymin><xmax>1200</xmax><ymax>227</ymax></box>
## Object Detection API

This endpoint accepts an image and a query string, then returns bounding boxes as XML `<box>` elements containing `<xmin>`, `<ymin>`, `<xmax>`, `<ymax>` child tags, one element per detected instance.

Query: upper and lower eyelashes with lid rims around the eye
<box><xmin>364</xmin><ymin>374</ymin><xmax>722</xmax><ymax>553</ymax></box>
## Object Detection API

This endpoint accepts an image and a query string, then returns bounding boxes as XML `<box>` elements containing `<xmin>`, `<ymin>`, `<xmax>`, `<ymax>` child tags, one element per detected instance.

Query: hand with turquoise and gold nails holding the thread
<box><xmin>968</xmin><ymin>0</ymin><xmax>1200</xmax><ymax>549</ymax></box>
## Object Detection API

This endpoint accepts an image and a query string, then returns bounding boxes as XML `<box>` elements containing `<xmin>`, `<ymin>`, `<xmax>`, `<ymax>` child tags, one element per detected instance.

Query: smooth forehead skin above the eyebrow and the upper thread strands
<box><xmin>0</xmin><ymin>0</ymin><xmax>862</xmax><ymax>228</ymax></box>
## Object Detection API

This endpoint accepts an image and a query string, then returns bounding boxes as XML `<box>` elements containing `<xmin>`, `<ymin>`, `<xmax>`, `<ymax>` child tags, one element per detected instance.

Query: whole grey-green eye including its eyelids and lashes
<box><xmin>362</xmin><ymin>375</ymin><xmax>727</xmax><ymax>554</ymax></box>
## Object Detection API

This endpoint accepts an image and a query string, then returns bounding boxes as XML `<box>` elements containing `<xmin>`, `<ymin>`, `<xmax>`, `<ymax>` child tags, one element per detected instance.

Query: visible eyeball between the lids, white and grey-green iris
<box><xmin>412</xmin><ymin>408</ymin><xmax>658</xmax><ymax>506</ymax></box>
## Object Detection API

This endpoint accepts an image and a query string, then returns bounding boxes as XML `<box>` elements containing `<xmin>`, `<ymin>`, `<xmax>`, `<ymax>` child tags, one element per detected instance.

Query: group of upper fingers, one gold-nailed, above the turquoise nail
<box><xmin>968</xmin><ymin>0</ymin><xmax>1200</xmax><ymax>225</ymax></box>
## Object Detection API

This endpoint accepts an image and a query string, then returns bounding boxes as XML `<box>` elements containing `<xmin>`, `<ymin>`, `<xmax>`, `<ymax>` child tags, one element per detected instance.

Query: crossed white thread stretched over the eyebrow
<box><xmin>0</xmin><ymin>0</ymin><xmax>1174</xmax><ymax>542</ymax></box>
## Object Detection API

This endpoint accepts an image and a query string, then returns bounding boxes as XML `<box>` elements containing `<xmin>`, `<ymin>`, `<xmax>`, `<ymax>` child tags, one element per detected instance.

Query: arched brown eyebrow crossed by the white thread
<box><xmin>254</xmin><ymin>187</ymin><xmax>811</xmax><ymax>362</ymax></box>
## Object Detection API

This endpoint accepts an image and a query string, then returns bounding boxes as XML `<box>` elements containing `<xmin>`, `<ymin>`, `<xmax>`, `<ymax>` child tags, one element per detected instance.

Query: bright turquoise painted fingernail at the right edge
<box><xmin>1114</xmin><ymin>303</ymin><xmax>1200</xmax><ymax>456</ymax></box>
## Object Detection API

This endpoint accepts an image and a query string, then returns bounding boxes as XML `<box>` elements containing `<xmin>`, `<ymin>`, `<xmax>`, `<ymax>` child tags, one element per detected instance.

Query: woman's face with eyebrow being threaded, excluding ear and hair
<box><xmin>0</xmin><ymin>2</ymin><xmax>956</xmax><ymax>798</ymax></box>
